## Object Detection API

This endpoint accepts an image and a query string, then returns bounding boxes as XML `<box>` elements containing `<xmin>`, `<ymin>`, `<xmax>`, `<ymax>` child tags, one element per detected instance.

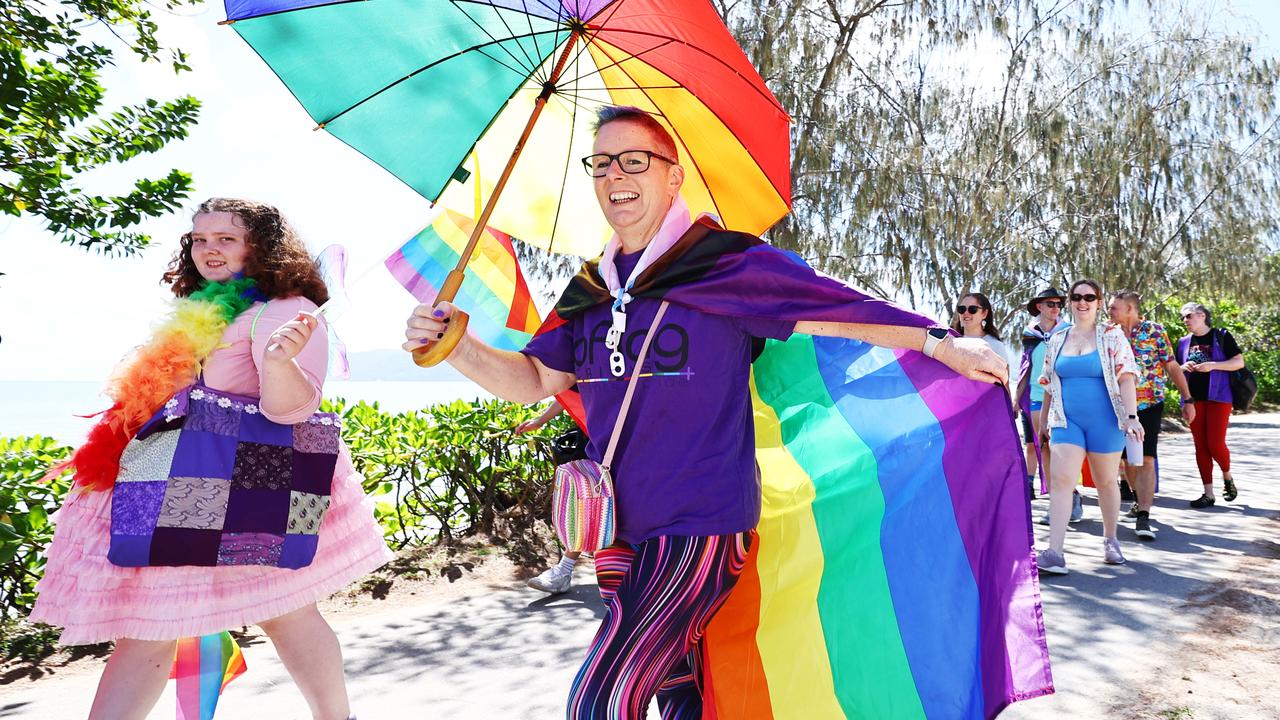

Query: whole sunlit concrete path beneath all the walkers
<box><xmin>0</xmin><ymin>415</ymin><xmax>1280</xmax><ymax>720</ymax></box>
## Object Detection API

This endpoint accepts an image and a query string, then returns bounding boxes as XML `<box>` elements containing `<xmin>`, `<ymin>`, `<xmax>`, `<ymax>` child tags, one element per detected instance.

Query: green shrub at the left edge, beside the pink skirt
<box><xmin>0</xmin><ymin>436</ymin><xmax>72</xmax><ymax>618</ymax></box>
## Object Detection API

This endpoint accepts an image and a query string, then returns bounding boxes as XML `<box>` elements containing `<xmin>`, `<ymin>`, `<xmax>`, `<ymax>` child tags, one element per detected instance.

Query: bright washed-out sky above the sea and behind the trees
<box><xmin>0</xmin><ymin>0</ymin><xmax>1280</xmax><ymax>380</ymax></box>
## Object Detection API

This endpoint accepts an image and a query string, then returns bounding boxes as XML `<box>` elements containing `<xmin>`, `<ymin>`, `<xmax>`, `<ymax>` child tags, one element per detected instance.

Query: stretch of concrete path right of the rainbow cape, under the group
<box><xmin>1001</xmin><ymin>414</ymin><xmax>1280</xmax><ymax>720</ymax></box>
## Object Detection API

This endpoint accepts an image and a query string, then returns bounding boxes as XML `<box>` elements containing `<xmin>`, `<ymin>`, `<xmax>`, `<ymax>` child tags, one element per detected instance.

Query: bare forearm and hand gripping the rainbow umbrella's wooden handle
<box><xmin>401</xmin><ymin>302</ymin><xmax>575</xmax><ymax>405</ymax></box>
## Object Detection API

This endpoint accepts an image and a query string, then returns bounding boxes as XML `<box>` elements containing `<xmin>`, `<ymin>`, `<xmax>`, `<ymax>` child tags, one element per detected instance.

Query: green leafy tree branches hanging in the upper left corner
<box><xmin>0</xmin><ymin>0</ymin><xmax>200</xmax><ymax>254</ymax></box>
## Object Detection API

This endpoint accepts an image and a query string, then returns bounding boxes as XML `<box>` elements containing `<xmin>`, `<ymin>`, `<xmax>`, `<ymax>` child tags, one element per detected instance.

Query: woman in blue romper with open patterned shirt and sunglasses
<box><xmin>1037</xmin><ymin>279</ymin><xmax>1143</xmax><ymax>575</ymax></box>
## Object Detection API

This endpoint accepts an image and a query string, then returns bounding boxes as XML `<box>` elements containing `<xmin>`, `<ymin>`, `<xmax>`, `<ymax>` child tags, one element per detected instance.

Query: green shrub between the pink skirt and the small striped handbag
<box><xmin>325</xmin><ymin>398</ymin><xmax>570</xmax><ymax>547</ymax></box>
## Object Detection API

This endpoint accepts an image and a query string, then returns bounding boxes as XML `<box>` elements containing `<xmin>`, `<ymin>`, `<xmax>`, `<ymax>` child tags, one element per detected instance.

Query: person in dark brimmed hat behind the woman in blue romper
<box><xmin>1014</xmin><ymin>287</ymin><xmax>1084</xmax><ymax>512</ymax></box>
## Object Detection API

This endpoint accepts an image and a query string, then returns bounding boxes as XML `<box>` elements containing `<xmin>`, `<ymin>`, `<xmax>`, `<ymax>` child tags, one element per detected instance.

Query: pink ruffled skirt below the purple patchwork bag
<box><xmin>31</xmin><ymin>446</ymin><xmax>392</xmax><ymax>644</ymax></box>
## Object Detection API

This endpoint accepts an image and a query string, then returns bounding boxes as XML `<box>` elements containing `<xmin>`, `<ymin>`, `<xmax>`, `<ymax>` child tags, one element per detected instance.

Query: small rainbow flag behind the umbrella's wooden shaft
<box><xmin>385</xmin><ymin>210</ymin><xmax>541</xmax><ymax>350</ymax></box>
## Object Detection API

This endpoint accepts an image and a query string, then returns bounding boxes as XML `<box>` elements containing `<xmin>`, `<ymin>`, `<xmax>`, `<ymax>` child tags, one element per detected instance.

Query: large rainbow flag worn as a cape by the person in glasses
<box><xmin>544</xmin><ymin>219</ymin><xmax>1053</xmax><ymax>720</ymax></box>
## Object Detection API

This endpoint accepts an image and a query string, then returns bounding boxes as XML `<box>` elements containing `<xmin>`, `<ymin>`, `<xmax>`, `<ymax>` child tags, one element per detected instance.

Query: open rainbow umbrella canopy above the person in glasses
<box><xmin>225</xmin><ymin>0</ymin><xmax>791</xmax><ymax>256</ymax></box>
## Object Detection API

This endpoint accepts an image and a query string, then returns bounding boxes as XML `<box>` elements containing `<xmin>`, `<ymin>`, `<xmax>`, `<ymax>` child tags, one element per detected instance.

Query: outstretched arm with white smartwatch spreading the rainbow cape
<box><xmin>795</xmin><ymin>320</ymin><xmax>1009</xmax><ymax>383</ymax></box>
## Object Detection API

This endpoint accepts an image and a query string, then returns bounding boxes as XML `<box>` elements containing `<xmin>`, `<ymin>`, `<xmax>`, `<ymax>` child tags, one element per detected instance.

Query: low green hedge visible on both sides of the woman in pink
<box><xmin>0</xmin><ymin>398</ymin><xmax>571</xmax><ymax>622</ymax></box>
